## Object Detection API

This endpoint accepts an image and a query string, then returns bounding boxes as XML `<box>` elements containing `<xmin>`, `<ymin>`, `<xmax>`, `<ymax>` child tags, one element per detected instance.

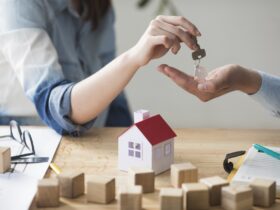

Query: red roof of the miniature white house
<box><xmin>134</xmin><ymin>115</ymin><xmax>176</xmax><ymax>145</ymax></box>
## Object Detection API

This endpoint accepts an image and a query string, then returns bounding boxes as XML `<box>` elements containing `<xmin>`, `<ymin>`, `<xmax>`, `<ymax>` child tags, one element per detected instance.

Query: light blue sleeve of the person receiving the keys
<box><xmin>251</xmin><ymin>71</ymin><xmax>280</xmax><ymax>117</ymax></box>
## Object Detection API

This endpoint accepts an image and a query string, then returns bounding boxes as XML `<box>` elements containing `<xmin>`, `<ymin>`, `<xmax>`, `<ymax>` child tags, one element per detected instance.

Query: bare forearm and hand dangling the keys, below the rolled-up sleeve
<box><xmin>71</xmin><ymin>16</ymin><xmax>200</xmax><ymax>124</ymax></box>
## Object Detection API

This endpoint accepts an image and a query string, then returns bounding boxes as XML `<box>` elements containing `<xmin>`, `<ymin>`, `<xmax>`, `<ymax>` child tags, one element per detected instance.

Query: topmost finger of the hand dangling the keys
<box><xmin>157</xmin><ymin>15</ymin><xmax>201</xmax><ymax>36</ymax></box>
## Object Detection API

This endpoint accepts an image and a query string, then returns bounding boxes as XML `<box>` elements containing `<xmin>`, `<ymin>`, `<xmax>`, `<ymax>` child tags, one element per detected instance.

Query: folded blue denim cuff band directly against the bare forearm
<box><xmin>49</xmin><ymin>83</ymin><xmax>95</xmax><ymax>136</ymax></box>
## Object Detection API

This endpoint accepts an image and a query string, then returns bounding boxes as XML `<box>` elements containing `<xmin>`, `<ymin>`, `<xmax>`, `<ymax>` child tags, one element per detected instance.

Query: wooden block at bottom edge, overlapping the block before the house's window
<box><xmin>119</xmin><ymin>185</ymin><xmax>142</xmax><ymax>210</ymax></box>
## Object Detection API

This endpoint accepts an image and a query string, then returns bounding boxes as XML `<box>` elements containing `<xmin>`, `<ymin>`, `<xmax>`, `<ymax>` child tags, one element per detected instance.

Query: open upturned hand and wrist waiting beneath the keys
<box><xmin>158</xmin><ymin>64</ymin><xmax>261</xmax><ymax>102</ymax></box>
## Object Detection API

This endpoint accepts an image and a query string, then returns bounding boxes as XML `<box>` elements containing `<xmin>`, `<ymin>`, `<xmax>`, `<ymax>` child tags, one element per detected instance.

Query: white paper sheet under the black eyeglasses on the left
<box><xmin>0</xmin><ymin>127</ymin><xmax>61</xmax><ymax>210</ymax></box>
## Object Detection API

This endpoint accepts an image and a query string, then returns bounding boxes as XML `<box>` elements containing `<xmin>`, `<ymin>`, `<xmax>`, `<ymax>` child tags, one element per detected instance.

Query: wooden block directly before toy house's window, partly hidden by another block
<box><xmin>128</xmin><ymin>168</ymin><xmax>155</xmax><ymax>193</ymax></box>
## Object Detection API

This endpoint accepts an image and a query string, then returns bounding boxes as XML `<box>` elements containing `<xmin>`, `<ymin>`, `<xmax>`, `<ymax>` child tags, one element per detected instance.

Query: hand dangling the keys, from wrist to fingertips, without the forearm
<box><xmin>130</xmin><ymin>15</ymin><xmax>201</xmax><ymax>67</ymax></box>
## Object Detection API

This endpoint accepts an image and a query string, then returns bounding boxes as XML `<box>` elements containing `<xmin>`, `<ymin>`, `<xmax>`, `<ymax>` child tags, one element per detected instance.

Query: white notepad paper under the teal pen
<box><xmin>232</xmin><ymin>147</ymin><xmax>280</xmax><ymax>197</ymax></box>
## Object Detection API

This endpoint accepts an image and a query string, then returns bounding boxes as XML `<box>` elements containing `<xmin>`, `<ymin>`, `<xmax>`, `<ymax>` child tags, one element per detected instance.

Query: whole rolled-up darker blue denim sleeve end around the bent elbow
<box><xmin>33</xmin><ymin>80</ymin><xmax>94</xmax><ymax>136</ymax></box>
